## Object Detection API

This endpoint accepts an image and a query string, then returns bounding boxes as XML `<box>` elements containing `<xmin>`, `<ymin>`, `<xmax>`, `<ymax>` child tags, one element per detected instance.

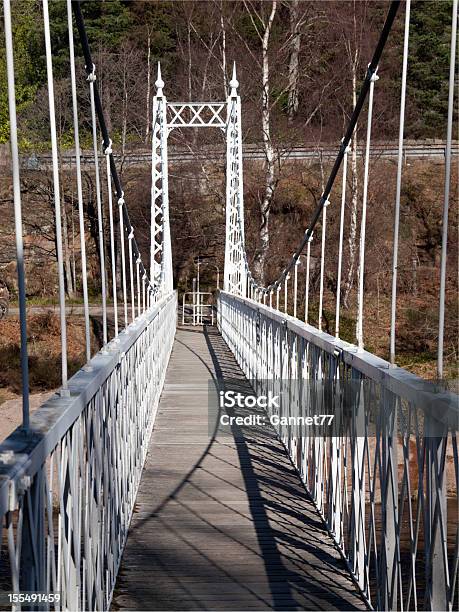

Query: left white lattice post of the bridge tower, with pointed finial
<box><xmin>150</xmin><ymin>64</ymin><xmax>172</xmax><ymax>293</ymax></box>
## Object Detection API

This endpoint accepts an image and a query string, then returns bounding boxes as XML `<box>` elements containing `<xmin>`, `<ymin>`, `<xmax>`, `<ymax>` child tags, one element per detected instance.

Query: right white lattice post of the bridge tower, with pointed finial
<box><xmin>223</xmin><ymin>66</ymin><xmax>247</xmax><ymax>297</ymax></box>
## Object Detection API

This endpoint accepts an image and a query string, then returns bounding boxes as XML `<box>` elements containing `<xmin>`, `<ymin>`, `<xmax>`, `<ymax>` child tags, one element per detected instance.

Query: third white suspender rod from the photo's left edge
<box><xmin>67</xmin><ymin>0</ymin><xmax>91</xmax><ymax>364</ymax></box>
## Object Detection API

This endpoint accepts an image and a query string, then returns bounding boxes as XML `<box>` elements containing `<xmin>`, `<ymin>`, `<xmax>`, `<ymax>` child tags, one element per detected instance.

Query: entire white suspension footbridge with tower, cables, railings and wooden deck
<box><xmin>0</xmin><ymin>0</ymin><xmax>459</xmax><ymax>610</ymax></box>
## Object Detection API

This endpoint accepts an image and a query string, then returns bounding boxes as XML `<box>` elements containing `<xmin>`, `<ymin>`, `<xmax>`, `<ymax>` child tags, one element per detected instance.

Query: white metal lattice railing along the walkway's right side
<box><xmin>217</xmin><ymin>292</ymin><xmax>459</xmax><ymax>610</ymax></box>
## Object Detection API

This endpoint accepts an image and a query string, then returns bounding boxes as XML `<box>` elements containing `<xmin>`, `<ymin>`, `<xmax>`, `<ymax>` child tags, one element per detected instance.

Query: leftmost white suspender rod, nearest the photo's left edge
<box><xmin>3</xmin><ymin>0</ymin><xmax>29</xmax><ymax>432</ymax></box>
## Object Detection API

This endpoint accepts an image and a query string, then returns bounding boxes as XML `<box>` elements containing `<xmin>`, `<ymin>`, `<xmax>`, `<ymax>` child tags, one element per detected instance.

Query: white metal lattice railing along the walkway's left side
<box><xmin>0</xmin><ymin>293</ymin><xmax>177</xmax><ymax>610</ymax></box>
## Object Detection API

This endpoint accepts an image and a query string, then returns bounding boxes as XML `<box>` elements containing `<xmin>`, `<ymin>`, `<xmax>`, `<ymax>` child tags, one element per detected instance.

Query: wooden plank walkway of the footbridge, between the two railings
<box><xmin>113</xmin><ymin>328</ymin><xmax>365</xmax><ymax>610</ymax></box>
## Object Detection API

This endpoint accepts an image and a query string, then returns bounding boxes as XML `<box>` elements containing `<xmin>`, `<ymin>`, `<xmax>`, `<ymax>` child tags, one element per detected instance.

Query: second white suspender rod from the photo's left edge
<box><xmin>43</xmin><ymin>0</ymin><xmax>69</xmax><ymax>396</ymax></box>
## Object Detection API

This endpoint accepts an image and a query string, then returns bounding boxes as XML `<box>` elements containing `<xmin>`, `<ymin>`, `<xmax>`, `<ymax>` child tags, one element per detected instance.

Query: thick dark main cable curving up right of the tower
<box><xmin>238</xmin><ymin>0</ymin><xmax>400</xmax><ymax>292</ymax></box>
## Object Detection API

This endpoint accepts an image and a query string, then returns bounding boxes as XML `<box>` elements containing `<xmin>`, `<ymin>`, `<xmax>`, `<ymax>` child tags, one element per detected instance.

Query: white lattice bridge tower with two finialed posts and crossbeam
<box><xmin>150</xmin><ymin>66</ymin><xmax>246</xmax><ymax>296</ymax></box>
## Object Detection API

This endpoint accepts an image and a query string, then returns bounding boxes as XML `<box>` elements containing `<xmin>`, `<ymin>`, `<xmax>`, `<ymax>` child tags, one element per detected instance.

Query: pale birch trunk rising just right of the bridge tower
<box><xmin>254</xmin><ymin>0</ymin><xmax>277</xmax><ymax>283</ymax></box>
